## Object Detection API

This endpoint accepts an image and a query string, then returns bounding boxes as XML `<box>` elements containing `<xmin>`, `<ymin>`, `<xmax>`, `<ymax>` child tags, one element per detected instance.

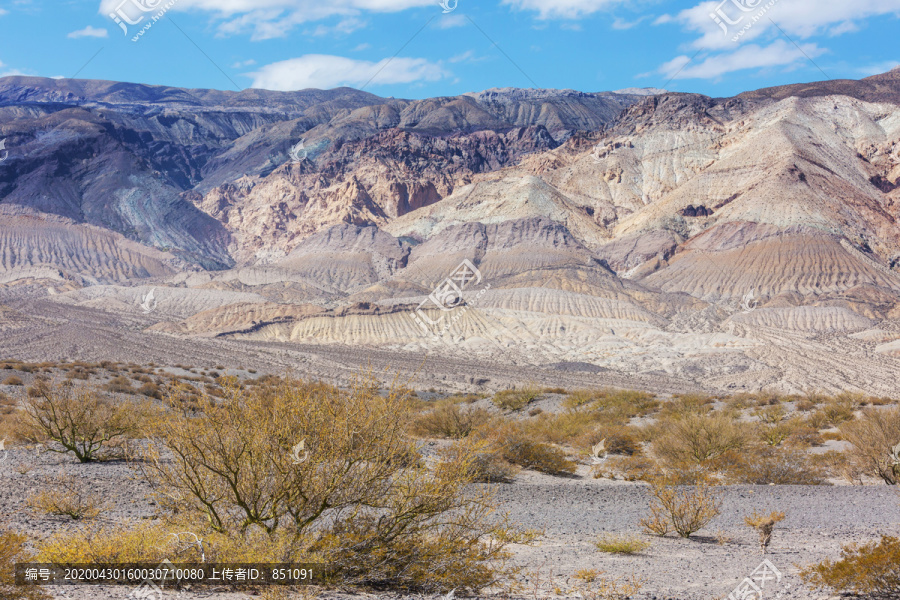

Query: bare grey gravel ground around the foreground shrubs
<box><xmin>0</xmin><ymin>448</ymin><xmax>900</xmax><ymax>600</ymax></box>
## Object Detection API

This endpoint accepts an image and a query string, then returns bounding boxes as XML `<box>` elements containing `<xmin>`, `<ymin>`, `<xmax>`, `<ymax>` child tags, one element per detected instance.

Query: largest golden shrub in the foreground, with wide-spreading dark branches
<box><xmin>142</xmin><ymin>379</ymin><xmax>517</xmax><ymax>591</ymax></box>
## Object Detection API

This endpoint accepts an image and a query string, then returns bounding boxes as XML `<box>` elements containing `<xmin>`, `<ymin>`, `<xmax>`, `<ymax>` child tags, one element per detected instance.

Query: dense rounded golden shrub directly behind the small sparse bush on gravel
<box><xmin>652</xmin><ymin>411</ymin><xmax>748</xmax><ymax>469</ymax></box>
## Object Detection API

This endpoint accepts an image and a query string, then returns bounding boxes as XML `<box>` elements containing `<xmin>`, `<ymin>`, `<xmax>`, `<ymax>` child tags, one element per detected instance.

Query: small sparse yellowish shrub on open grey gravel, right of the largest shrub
<box><xmin>640</xmin><ymin>479</ymin><xmax>722</xmax><ymax>538</ymax></box>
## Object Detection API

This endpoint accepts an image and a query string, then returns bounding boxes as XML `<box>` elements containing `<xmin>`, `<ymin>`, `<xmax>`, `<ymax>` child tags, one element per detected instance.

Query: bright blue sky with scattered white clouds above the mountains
<box><xmin>0</xmin><ymin>0</ymin><xmax>900</xmax><ymax>98</ymax></box>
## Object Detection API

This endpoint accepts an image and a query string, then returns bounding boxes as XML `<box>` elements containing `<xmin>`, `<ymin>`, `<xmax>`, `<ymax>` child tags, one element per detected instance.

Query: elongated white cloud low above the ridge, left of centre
<box><xmin>248</xmin><ymin>54</ymin><xmax>450</xmax><ymax>91</ymax></box>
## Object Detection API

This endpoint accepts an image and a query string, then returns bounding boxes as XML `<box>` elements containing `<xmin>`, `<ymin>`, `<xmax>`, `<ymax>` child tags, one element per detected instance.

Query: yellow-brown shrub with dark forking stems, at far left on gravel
<box><xmin>22</xmin><ymin>383</ymin><xmax>146</xmax><ymax>463</ymax></box>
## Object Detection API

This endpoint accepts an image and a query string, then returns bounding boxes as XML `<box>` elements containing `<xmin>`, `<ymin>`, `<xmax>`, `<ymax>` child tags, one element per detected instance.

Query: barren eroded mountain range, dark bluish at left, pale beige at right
<box><xmin>0</xmin><ymin>69</ymin><xmax>900</xmax><ymax>394</ymax></box>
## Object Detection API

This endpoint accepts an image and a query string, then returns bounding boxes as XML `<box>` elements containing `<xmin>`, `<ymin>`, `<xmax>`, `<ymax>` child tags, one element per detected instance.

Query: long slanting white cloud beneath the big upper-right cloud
<box><xmin>659</xmin><ymin>40</ymin><xmax>825</xmax><ymax>79</ymax></box>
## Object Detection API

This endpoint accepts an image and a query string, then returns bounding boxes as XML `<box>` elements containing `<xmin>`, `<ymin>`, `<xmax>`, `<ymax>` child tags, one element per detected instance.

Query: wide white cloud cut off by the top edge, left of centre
<box><xmin>100</xmin><ymin>0</ymin><xmax>440</xmax><ymax>40</ymax></box>
